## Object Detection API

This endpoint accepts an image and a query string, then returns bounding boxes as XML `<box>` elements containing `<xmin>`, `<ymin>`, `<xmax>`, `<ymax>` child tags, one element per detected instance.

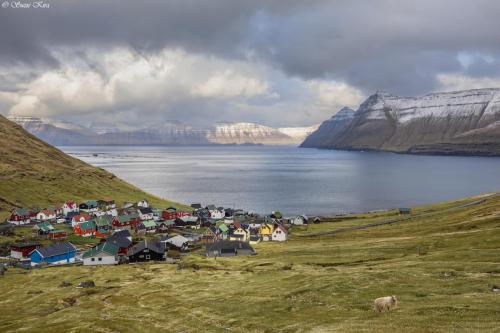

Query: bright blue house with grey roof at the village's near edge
<box><xmin>30</xmin><ymin>242</ymin><xmax>76</xmax><ymax>266</ymax></box>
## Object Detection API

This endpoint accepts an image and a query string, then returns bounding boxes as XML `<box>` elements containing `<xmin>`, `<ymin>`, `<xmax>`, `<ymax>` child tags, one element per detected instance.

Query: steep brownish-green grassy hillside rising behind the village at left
<box><xmin>0</xmin><ymin>116</ymin><xmax>188</xmax><ymax>218</ymax></box>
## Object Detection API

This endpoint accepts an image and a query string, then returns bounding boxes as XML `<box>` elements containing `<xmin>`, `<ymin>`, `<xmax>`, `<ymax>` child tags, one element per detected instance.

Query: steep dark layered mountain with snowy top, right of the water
<box><xmin>301</xmin><ymin>89</ymin><xmax>500</xmax><ymax>156</ymax></box>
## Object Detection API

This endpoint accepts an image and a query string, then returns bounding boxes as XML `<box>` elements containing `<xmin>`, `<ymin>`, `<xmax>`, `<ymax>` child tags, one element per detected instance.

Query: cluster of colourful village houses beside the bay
<box><xmin>1</xmin><ymin>198</ymin><xmax>320</xmax><ymax>268</ymax></box>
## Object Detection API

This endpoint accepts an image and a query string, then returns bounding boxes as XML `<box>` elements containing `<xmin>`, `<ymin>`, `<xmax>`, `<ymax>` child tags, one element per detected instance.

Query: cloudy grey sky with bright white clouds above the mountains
<box><xmin>0</xmin><ymin>0</ymin><xmax>500</xmax><ymax>126</ymax></box>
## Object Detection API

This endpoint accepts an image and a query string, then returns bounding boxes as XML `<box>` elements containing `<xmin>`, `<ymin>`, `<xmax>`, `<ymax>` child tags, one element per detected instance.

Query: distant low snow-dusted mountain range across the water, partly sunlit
<box><xmin>9</xmin><ymin>117</ymin><xmax>317</xmax><ymax>145</ymax></box>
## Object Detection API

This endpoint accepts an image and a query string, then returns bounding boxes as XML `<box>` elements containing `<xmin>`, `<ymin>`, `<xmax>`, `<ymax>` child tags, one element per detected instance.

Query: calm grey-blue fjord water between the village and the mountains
<box><xmin>60</xmin><ymin>146</ymin><xmax>500</xmax><ymax>215</ymax></box>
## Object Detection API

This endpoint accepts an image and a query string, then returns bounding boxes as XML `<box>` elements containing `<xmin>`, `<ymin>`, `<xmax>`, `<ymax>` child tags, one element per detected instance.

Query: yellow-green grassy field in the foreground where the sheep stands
<box><xmin>0</xmin><ymin>193</ymin><xmax>500</xmax><ymax>332</ymax></box>
